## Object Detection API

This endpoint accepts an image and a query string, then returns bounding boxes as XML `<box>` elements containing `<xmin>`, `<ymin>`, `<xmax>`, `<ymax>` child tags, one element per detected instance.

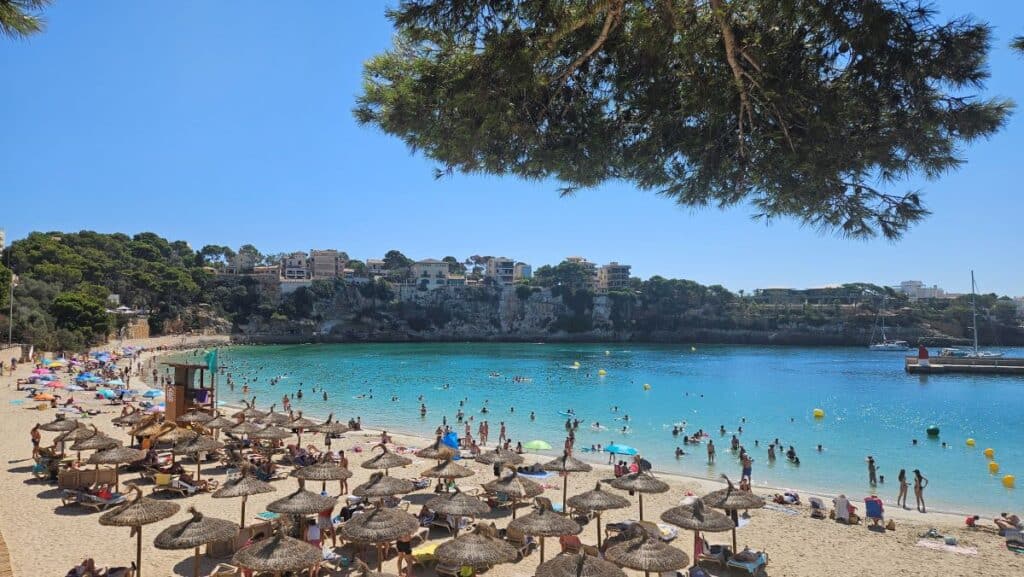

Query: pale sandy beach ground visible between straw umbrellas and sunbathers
<box><xmin>0</xmin><ymin>337</ymin><xmax>1024</xmax><ymax>577</ymax></box>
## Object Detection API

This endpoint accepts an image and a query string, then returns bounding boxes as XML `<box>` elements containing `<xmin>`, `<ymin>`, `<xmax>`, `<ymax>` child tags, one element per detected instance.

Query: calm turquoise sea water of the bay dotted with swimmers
<box><xmin>211</xmin><ymin>343</ymin><xmax>1024</xmax><ymax>514</ymax></box>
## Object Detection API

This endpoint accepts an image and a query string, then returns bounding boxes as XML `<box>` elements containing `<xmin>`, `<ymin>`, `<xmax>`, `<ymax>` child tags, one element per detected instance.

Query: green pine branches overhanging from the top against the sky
<box><xmin>354</xmin><ymin>0</ymin><xmax>1011</xmax><ymax>238</ymax></box>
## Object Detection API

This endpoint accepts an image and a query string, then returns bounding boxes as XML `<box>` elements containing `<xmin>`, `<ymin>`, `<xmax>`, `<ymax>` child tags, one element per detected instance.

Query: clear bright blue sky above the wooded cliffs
<box><xmin>0</xmin><ymin>0</ymin><xmax>1024</xmax><ymax>295</ymax></box>
